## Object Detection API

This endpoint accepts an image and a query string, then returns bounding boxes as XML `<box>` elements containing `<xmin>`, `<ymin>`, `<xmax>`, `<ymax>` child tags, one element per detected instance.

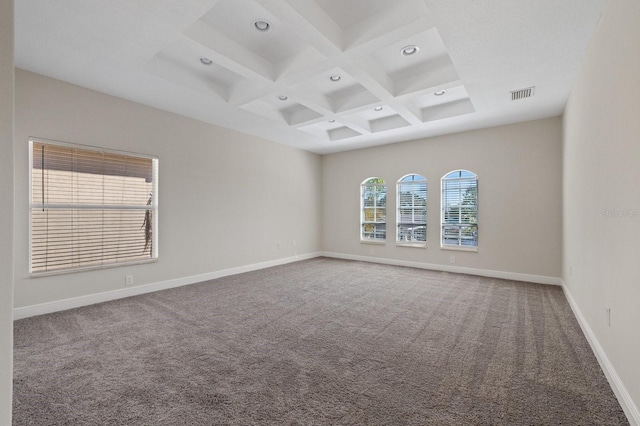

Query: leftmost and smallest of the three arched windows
<box><xmin>360</xmin><ymin>177</ymin><xmax>387</xmax><ymax>241</ymax></box>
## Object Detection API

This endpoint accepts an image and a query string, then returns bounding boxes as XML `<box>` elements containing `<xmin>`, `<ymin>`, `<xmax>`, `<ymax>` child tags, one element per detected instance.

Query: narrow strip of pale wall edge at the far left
<box><xmin>0</xmin><ymin>0</ymin><xmax>14</xmax><ymax>425</ymax></box>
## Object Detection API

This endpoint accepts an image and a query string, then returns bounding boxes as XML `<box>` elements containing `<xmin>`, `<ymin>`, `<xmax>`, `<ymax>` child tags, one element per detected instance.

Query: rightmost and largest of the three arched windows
<box><xmin>442</xmin><ymin>170</ymin><xmax>478</xmax><ymax>249</ymax></box>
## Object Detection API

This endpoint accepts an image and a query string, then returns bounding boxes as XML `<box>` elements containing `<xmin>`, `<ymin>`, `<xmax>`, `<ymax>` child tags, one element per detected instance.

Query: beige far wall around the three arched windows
<box><xmin>322</xmin><ymin>118</ymin><xmax>562</xmax><ymax>283</ymax></box>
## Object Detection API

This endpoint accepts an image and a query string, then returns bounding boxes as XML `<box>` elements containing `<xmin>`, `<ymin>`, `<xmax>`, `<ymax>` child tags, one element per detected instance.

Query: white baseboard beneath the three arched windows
<box><xmin>321</xmin><ymin>252</ymin><xmax>562</xmax><ymax>286</ymax></box>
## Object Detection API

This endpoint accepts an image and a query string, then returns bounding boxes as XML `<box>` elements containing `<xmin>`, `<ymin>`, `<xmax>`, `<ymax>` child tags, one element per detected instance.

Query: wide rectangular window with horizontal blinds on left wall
<box><xmin>29</xmin><ymin>139</ymin><xmax>158</xmax><ymax>274</ymax></box>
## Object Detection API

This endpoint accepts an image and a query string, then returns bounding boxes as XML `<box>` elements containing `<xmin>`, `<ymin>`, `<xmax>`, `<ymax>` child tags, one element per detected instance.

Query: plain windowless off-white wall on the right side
<box><xmin>563</xmin><ymin>0</ymin><xmax>640</xmax><ymax>424</ymax></box>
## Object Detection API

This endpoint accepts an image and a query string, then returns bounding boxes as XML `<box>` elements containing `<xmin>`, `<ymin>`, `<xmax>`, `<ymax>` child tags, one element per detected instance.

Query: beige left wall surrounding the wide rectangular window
<box><xmin>15</xmin><ymin>70</ymin><xmax>321</xmax><ymax>308</ymax></box>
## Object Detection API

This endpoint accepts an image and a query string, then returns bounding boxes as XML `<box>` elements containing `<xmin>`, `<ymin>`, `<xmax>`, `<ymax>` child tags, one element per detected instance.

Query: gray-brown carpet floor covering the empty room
<box><xmin>13</xmin><ymin>258</ymin><xmax>628</xmax><ymax>426</ymax></box>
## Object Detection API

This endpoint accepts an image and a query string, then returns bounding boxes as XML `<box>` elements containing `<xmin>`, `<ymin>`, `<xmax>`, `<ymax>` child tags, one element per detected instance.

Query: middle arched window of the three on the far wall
<box><xmin>396</xmin><ymin>174</ymin><xmax>427</xmax><ymax>246</ymax></box>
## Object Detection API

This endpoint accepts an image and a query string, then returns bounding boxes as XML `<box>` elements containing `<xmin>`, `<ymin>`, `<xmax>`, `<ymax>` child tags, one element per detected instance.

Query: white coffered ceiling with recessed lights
<box><xmin>15</xmin><ymin>0</ymin><xmax>606</xmax><ymax>153</ymax></box>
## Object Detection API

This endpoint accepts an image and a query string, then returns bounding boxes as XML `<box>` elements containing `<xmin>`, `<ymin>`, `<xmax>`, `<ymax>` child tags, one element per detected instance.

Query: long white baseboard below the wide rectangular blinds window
<box><xmin>13</xmin><ymin>253</ymin><xmax>320</xmax><ymax>320</ymax></box>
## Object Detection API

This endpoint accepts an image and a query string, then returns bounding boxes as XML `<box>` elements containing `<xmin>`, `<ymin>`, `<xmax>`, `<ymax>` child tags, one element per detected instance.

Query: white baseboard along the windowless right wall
<box><xmin>562</xmin><ymin>283</ymin><xmax>640</xmax><ymax>426</ymax></box>
